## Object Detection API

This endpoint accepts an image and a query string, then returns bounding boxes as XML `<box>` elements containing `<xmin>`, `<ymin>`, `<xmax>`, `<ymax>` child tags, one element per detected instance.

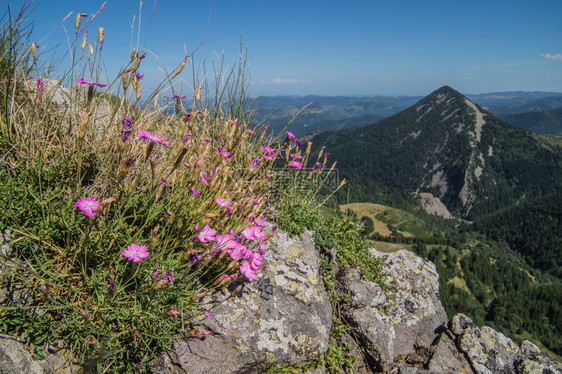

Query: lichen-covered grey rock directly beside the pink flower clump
<box><xmin>164</xmin><ymin>231</ymin><xmax>332</xmax><ymax>374</ymax></box>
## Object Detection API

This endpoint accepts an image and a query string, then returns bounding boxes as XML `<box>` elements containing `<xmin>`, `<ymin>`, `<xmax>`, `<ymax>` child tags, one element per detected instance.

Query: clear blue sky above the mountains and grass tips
<box><xmin>7</xmin><ymin>0</ymin><xmax>562</xmax><ymax>96</ymax></box>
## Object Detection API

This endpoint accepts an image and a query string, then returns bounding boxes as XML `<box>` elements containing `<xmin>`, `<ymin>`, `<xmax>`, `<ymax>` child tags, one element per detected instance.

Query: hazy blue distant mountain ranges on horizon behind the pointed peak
<box><xmin>255</xmin><ymin>91</ymin><xmax>562</xmax><ymax>135</ymax></box>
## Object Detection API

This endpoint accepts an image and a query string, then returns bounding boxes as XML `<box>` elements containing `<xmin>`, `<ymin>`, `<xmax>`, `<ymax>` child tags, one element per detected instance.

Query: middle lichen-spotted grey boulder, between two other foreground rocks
<box><xmin>342</xmin><ymin>250</ymin><xmax>447</xmax><ymax>371</ymax></box>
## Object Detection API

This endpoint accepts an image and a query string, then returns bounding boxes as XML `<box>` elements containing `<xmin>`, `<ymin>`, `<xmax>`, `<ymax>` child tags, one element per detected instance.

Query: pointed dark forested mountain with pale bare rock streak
<box><xmin>313</xmin><ymin>86</ymin><xmax>562</xmax><ymax>219</ymax></box>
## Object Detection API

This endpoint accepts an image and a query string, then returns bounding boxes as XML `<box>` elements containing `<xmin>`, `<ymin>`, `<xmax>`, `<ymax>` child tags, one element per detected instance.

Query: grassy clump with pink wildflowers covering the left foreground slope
<box><xmin>0</xmin><ymin>2</ymin><xmax>333</xmax><ymax>372</ymax></box>
